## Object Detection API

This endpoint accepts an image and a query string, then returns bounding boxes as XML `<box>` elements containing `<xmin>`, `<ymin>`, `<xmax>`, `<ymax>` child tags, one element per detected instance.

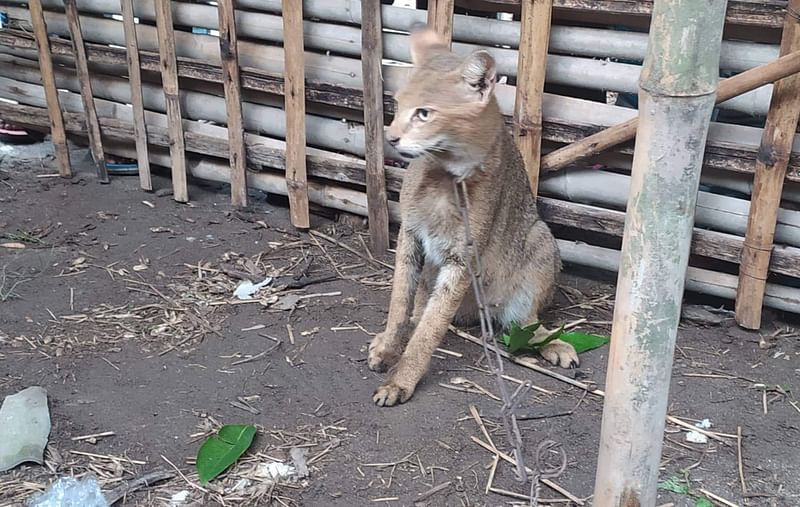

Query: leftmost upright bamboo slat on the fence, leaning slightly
<box><xmin>28</xmin><ymin>0</ymin><xmax>72</xmax><ymax>178</ymax></box>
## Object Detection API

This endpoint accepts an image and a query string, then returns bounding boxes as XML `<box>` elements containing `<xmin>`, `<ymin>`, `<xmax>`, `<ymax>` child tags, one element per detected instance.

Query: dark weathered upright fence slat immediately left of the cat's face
<box><xmin>361</xmin><ymin>0</ymin><xmax>389</xmax><ymax>257</ymax></box>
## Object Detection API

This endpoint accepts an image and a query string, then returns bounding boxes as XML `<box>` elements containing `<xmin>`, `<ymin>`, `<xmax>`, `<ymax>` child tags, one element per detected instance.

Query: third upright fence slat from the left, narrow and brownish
<box><xmin>120</xmin><ymin>0</ymin><xmax>153</xmax><ymax>191</ymax></box>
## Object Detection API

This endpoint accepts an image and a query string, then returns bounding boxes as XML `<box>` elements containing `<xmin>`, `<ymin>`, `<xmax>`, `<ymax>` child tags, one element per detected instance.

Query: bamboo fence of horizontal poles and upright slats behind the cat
<box><xmin>0</xmin><ymin>0</ymin><xmax>800</xmax><ymax>327</ymax></box>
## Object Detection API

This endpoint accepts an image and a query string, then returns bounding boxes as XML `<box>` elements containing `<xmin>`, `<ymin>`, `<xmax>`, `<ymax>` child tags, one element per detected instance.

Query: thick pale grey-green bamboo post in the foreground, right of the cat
<box><xmin>594</xmin><ymin>0</ymin><xmax>727</xmax><ymax>507</ymax></box>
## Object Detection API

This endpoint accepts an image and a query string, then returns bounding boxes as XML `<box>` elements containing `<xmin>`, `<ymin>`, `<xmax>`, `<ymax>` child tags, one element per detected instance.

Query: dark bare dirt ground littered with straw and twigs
<box><xmin>0</xmin><ymin>143</ymin><xmax>800</xmax><ymax>506</ymax></box>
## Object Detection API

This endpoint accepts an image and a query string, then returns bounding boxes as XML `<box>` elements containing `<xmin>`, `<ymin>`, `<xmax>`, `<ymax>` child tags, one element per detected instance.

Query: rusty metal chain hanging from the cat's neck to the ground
<box><xmin>453</xmin><ymin>179</ymin><xmax>567</xmax><ymax>507</ymax></box>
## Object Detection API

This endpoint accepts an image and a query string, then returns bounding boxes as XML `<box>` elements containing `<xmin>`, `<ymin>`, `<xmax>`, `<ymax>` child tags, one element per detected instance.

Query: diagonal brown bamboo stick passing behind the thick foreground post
<box><xmin>542</xmin><ymin>51</ymin><xmax>800</xmax><ymax>172</ymax></box>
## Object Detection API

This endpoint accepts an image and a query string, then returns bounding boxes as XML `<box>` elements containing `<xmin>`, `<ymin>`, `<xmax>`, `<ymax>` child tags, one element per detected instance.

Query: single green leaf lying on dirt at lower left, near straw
<box><xmin>196</xmin><ymin>424</ymin><xmax>256</xmax><ymax>485</ymax></box>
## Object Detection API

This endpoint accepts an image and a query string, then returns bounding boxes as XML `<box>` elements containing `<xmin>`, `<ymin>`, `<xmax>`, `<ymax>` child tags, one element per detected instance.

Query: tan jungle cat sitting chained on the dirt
<box><xmin>368</xmin><ymin>28</ymin><xmax>578</xmax><ymax>406</ymax></box>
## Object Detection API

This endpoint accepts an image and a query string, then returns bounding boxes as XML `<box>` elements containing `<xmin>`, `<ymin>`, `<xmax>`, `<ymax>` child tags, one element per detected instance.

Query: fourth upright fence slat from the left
<box><xmin>155</xmin><ymin>0</ymin><xmax>189</xmax><ymax>202</ymax></box>
